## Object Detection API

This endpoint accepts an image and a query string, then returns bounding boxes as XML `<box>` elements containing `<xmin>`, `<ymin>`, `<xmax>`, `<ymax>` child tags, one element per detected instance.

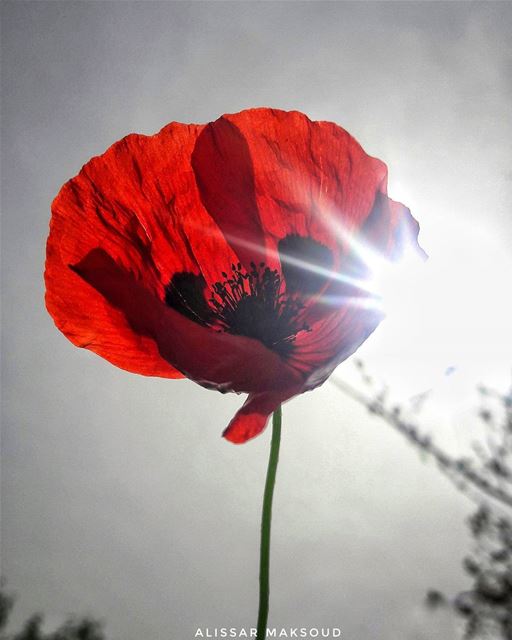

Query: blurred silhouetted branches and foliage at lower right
<box><xmin>335</xmin><ymin>361</ymin><xmax>512</xmax><ymax>640</ymax></box>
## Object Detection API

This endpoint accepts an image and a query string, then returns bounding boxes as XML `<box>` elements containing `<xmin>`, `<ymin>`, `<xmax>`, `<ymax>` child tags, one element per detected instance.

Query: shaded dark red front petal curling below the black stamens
<box><xmin>73</xmin><ymin>249</ymin><xmax>302</xmax><ymax>393</ymax></box>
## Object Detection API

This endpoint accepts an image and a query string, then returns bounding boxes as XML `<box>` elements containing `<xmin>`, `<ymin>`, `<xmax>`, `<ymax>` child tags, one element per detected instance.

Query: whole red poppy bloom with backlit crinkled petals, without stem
<box><xmin>45</xmin><ymin>109</ymin><xmax>418</xmax><ymax>443</ymax></box>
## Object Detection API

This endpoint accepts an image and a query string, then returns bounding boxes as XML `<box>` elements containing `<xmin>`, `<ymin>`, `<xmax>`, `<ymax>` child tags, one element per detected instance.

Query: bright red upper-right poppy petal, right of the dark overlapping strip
<box><xmin>220</xmin><ymin>109</ymin><xmax>386</xmax><ymax>268</ymax></box>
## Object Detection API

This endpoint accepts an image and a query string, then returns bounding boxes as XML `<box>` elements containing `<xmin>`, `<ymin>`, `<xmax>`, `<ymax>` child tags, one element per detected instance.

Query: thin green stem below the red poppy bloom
<box><xmin>256</xmin><ymin>407</ymin><xmax>282</xmax><ymax>640</ymax></box>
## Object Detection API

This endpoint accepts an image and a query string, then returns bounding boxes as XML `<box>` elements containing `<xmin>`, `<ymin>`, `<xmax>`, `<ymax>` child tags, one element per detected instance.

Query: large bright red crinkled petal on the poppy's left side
<box><xmin>45</xmin><ymin>123</ymin><xmax>237</xmax><ymax>378</ymax></box>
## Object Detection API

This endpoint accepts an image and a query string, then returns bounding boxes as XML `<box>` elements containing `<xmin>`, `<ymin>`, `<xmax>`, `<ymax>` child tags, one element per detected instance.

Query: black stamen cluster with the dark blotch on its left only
<box><xmin>165</xmin><ymin>262</ymin><xmax>309</xmax><ymax>356</ymax></box>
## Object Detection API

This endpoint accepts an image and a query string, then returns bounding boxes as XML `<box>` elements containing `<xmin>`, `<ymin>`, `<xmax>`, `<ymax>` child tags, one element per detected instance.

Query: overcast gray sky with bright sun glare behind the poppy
<box><xmin>1</xmin><ymin>1</ymin><xmax>512</xmax><ymax>640</ymax></box>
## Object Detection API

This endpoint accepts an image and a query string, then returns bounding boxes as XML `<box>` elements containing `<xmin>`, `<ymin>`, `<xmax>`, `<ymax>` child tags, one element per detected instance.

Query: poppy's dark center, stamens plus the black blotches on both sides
<box><xmin>165</xmin><ymin>235</ymin><xmax>332</xmax><ymax>356</ymax></box>
